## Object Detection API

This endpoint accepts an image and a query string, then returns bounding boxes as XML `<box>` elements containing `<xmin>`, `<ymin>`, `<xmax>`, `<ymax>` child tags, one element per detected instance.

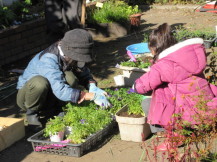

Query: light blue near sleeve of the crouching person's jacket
<box><xmin>38</xmin><ymin>55</ymin><xmax>80</xmax><ymax>103</ymax></box>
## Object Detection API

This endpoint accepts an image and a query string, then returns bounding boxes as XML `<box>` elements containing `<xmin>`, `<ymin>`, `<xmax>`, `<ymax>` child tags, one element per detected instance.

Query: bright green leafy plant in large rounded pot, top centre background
<box><xmin>87</xmin><ymin>1</ymin><xmax>139</xmax><ymax>36</ymax></box>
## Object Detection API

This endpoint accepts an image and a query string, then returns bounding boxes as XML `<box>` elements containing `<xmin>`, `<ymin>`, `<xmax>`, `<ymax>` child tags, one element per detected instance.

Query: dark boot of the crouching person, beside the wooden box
<box><xmin>26</xmin><ymin>110</ymin><xmax>42</xmax><ymax>132</ymax></box>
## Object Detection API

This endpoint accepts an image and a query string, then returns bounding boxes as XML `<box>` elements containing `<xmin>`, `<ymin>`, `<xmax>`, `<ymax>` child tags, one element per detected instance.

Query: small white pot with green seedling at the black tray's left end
<box><xmin>44</xmin><ymin>116</ymin><xmax>65</xmax><ymax>142</ymax></box>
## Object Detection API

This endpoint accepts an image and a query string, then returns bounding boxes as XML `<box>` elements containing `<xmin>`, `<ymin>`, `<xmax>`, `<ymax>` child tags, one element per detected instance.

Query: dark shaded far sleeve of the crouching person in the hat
<box><xmin>73</xmin><ymin>67</ymin><xmax>96</xmax><ymax>89</ymax></box>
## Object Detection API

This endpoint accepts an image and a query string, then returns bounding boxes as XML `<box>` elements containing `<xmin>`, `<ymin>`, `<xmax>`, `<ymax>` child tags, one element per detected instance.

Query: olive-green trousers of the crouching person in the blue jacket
<box><xmin>17</xmin><ymin>71</ymin><xmax>78</xmax><ymax>111</ymax></box>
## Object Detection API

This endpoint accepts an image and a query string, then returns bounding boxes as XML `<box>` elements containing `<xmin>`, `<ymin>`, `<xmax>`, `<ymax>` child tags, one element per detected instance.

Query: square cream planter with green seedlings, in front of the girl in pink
<box><xmin>108</xmin><ymin>88</ymin><xmax>150</xmax><ymax>142</ymax></box>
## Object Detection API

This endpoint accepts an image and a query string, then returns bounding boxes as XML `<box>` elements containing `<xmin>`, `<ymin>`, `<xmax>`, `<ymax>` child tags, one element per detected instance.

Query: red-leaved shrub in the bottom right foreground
<box><xmin>142</xmin><ymin>83</ymin><xmax>217</xmax><ymax>161</ymax></box>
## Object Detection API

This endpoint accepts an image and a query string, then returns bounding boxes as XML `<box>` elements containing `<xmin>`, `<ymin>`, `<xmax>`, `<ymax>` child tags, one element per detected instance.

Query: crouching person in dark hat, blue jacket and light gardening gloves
<box><xmin>17</xmin><ymin>29</ymin><xmax>110</xmax><ymax>127</ymax></box>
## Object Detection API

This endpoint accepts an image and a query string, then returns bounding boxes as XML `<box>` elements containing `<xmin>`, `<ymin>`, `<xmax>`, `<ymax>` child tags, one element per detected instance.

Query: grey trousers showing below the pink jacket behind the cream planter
<box><xmin>142</xmin><ymin>98</ymin><xmax>164</xmax><ymax>133</ymax></box>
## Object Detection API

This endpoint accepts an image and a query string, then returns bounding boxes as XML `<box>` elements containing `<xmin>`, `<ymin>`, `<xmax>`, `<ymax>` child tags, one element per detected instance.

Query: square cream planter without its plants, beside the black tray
<box><xmin>115</xmin><ymin>106</ymin><xmax>151</xmax><ymax>142</ymax></box>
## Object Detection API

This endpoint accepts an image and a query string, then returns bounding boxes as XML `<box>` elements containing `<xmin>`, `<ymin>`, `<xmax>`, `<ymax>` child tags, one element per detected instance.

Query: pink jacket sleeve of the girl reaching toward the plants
<box><xmin>134</xmin><ymin>62</ymin><xmax>173</xmax><ymax>94</ymax></box>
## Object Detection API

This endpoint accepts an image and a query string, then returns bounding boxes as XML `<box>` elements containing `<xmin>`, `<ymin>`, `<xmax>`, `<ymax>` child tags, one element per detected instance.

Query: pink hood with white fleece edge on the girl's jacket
<box><xmin>158</xmin><ymin>38</ymin><xmax>206</xmax><ymax>74</ymax></box>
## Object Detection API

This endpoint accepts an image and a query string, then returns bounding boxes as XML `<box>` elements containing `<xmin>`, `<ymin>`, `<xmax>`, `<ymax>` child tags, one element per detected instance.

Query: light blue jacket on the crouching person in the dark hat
<box><xmin>17</xmin><ymin>43</ymin><xmax>93</xmax><ymax>103</ymax></box>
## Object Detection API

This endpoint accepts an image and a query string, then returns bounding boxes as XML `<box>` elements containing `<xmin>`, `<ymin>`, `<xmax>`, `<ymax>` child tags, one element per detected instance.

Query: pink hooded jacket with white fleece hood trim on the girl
<box><xmin>134</xmin><ymin>38</ymin><xmax>217</xmax><ymax>126</ymax></box>
